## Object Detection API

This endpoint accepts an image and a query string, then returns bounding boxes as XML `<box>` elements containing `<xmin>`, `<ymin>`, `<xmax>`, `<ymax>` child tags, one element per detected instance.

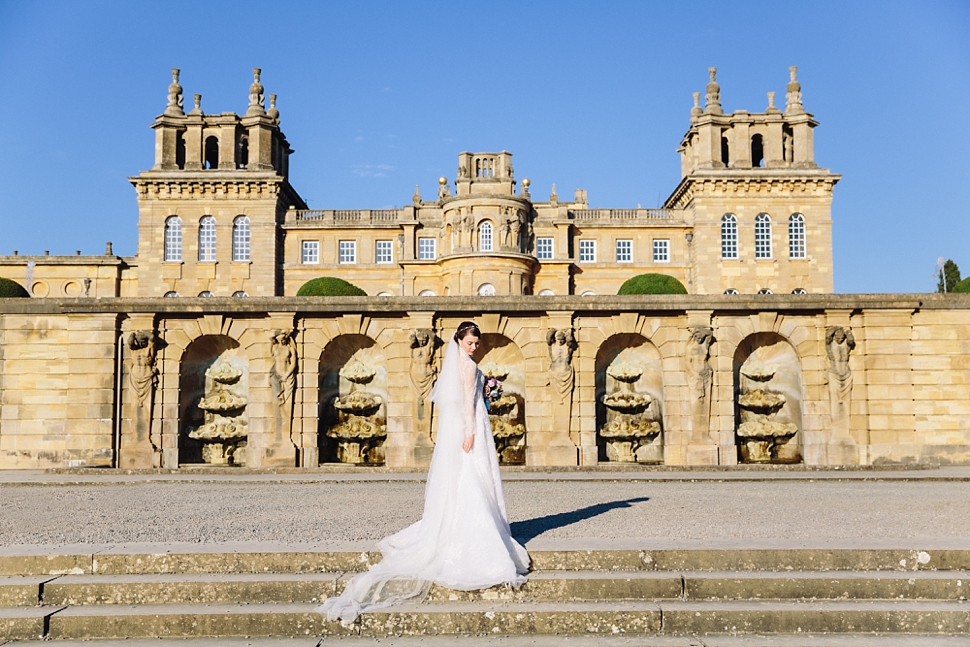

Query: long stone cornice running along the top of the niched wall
<box><xmin>0</xmin><ymin>293</ymin><xmax>970</xmax><ymax>317</ymax></box>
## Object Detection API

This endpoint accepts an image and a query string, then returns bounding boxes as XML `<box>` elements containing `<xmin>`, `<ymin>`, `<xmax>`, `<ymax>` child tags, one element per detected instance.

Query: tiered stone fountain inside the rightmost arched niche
<box><xmin>738</xmin><ymin>364</ymin><xmax>798</xmax><ymax>463</ymax></box>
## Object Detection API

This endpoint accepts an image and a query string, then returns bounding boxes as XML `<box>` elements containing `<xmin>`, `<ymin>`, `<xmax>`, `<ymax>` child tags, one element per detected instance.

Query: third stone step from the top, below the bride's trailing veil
<box><xmin>17</xmin><ymin>601</ymin><xmax>970</xmax><ymax>640</ymax></box>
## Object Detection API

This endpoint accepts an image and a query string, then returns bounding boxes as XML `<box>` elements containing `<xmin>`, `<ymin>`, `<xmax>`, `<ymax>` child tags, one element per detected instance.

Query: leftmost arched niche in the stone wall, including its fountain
<box><xmin>178</xmin><ymin>335</ymin><xmax>249</xmax><ymax>465</ymax></box>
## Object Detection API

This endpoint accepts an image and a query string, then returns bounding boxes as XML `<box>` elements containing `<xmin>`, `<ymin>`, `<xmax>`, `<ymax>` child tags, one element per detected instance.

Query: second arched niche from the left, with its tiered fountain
<box><xmin>317</xmin><ymin>335</ymin><xmax>388</xmax><ymax>465</ymax></box>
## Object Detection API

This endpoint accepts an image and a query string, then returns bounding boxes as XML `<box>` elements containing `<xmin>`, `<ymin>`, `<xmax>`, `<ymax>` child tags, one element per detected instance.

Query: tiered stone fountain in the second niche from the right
<box><xmin>600</xmin><ymin>362</ymin><xmax>663</xmax><ymax>463</ymax></box>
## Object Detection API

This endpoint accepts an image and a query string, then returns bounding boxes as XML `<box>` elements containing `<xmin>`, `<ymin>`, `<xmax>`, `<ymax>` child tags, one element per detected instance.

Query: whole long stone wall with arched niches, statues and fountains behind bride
<box><xmin>0</xmin><ymin>295</ymin><xmax>970</xmax><ymax>468</ymax></box>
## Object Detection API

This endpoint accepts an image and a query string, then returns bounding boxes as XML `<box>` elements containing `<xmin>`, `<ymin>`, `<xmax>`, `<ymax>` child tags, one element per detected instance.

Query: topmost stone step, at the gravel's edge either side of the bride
<box><xmin>0</xmin><ymin>546</ymin><xmax>970</xmax><ymax>576</ymax></box>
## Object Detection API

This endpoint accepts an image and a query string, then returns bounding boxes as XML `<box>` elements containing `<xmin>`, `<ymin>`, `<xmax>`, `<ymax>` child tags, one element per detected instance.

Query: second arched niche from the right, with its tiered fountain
<box><xmin>595</xmin><ymin>333</ymin><xmax>664</xmax><ymax>463</ymax></box>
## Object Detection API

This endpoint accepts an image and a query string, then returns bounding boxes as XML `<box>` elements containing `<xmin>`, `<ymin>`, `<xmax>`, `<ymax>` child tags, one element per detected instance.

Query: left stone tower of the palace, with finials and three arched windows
<box><xmin>129</xmin><ymin>68</ymin><xmax>306</xmax><ymax>297</ymax></box>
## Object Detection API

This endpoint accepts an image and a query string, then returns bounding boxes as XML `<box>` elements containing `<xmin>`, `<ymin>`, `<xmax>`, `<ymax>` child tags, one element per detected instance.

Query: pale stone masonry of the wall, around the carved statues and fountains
<box><xmin>0</xmin><ymin>295</ymin><xmax>970</xmax><ymax>468</ymax></box>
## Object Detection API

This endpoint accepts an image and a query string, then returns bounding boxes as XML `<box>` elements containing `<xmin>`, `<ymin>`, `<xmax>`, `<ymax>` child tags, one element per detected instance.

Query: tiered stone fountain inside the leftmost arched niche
<box><xmin>189</xmin><ymin>361</ymin><xmax>249</xmax><ymax>465</ymax></box>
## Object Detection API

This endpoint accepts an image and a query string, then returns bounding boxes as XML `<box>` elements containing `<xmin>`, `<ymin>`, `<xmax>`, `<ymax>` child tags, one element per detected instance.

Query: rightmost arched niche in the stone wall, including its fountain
<box><xmin>734</xmin><ymin>332</ymin><xmax>804</xmax><ymax>463</ymax></box>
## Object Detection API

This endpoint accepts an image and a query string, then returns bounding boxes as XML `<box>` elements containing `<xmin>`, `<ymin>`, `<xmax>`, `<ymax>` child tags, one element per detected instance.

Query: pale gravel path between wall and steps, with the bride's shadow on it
<box><xmin>0</xmin><ymin>481</ymin><xmax>970</xmax><ymax>546</ymax></box>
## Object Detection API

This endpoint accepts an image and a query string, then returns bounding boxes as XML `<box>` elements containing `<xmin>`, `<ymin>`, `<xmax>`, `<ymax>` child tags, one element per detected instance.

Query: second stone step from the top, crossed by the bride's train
<box><xmin>0</xmin><ymin>571</ymin><xmax>970</xmax><ymax>607</ymax></box>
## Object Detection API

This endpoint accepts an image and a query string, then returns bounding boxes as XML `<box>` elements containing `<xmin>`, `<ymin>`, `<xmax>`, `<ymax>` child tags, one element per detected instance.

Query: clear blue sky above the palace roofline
<box><xmin>0</xmin><ymin>0</ymin><xmax>970</xmax><ymax>292</ymax></box>
